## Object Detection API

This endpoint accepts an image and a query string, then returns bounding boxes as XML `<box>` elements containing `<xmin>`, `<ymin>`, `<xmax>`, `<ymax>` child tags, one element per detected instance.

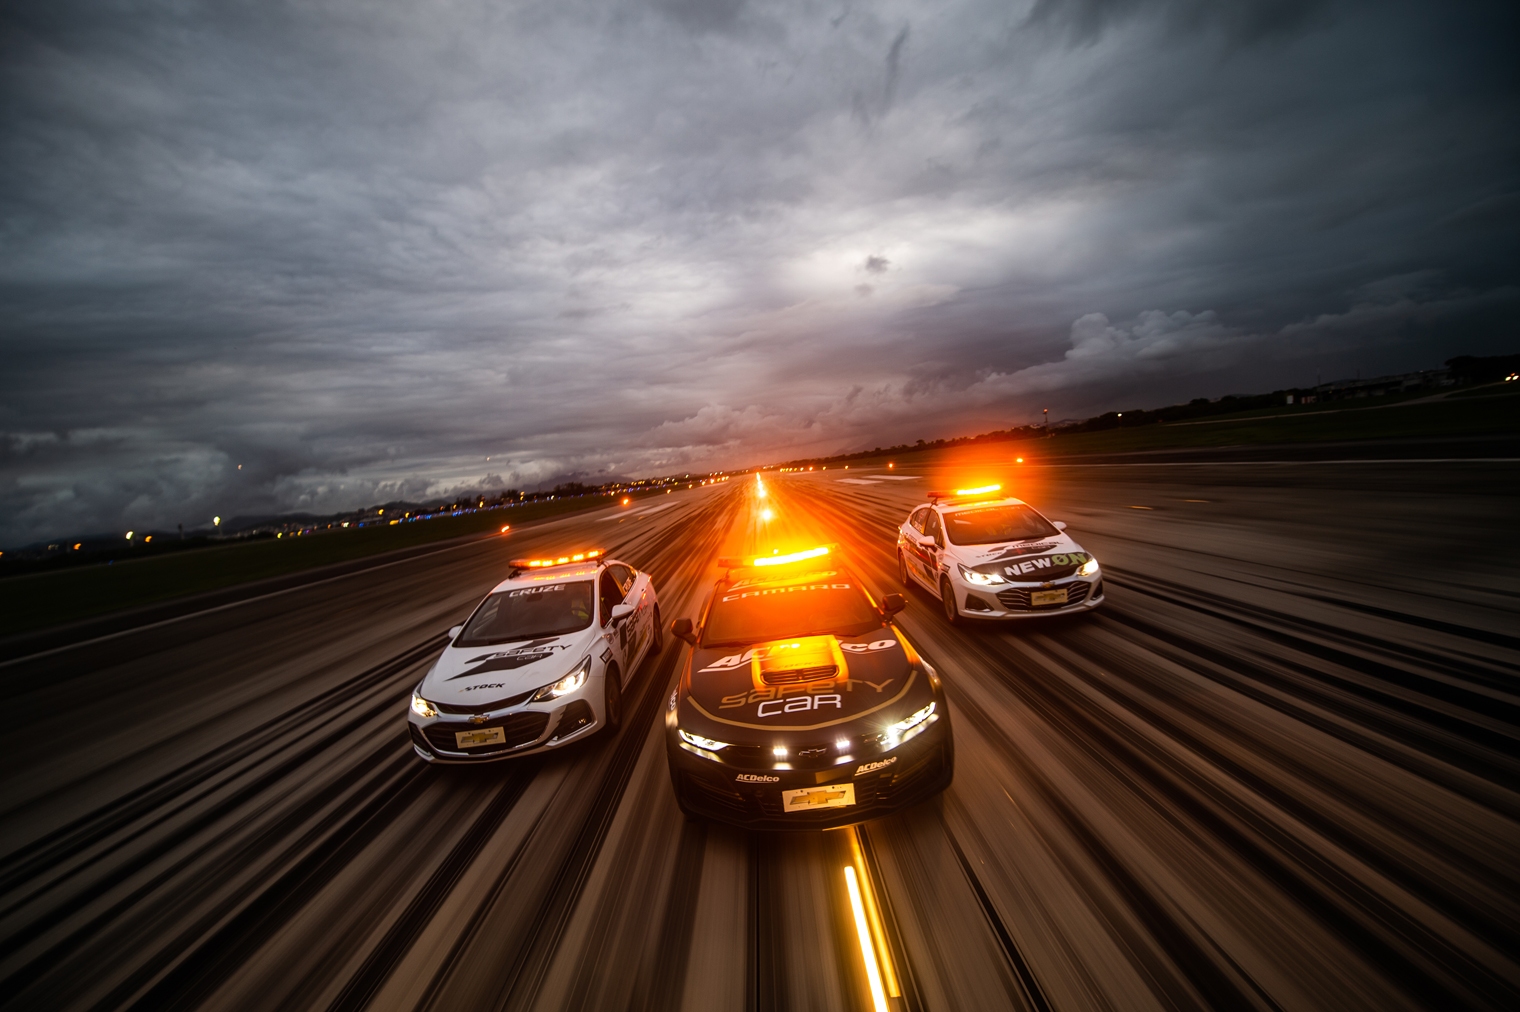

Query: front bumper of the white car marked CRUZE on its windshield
<box><xmin>407</xmin><ymin>675</ymin><xmax>605</xmax><ymax>764</ymax></box>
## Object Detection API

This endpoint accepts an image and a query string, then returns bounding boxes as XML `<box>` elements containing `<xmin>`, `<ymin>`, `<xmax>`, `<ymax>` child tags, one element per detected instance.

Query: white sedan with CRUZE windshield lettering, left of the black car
<box><xmin>407</xmin><ymin>552</ymin><xmax>663</xmax><ymax>763</ymax></box>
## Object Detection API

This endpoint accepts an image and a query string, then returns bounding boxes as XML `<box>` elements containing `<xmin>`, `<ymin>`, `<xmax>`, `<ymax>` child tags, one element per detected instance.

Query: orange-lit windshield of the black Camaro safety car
<box><xmin>702</xmin><ymin>571</ymin><xmax>882</xmax><ymax>646</ymax></box>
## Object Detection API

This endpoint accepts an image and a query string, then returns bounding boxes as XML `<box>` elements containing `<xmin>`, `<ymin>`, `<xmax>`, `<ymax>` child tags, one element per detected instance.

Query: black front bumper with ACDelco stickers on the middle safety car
<box><xmin>666</xmin><ymin>700</ymin><xmax>955</xmax><ymax>831</ymax></box>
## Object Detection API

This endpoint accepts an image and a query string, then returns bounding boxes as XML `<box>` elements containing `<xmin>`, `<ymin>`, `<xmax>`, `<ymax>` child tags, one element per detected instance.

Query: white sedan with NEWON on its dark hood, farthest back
<box><xmin>897</xmin><ymin>485</ymin><xmax>1104</xmax><ymax>625</ymax></box>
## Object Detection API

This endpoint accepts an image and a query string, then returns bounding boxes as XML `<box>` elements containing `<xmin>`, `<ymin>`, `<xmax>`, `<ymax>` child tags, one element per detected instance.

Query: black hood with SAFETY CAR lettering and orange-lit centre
<box><xmin>676</xmin><ymin>628</ymin><xmax>933</xmax><ymax>742</ymax></box>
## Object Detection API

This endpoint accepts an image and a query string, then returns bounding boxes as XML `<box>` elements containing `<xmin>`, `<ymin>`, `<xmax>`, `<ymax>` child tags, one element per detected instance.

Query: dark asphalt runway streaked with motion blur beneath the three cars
<box><xmin>0</xmin><ymin>462</ymin><xmax>1520</xmax><ymax>1012</ymax></box>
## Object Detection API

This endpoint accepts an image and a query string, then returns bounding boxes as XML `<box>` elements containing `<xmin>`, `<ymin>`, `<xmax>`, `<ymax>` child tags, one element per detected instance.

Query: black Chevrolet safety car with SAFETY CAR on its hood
<box><xmin>666</xmin><ymin>546</ymin><xmax>955</xmax><ymax>830</ymax></box>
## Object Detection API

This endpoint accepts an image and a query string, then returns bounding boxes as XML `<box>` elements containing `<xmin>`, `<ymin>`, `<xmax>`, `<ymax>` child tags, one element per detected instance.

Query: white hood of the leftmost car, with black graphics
<box><xmin>421</xmin><ymin>623</ymin><xmax>600</xmax><ymax>705</ymax></box>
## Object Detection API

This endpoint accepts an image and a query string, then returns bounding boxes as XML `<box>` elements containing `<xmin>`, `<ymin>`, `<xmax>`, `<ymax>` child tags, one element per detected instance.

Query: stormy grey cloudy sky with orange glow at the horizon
<box><xmin>0</xmin><ymin>0</ymin><xmax>1520</xmax><ymax>546</ymax></box>
